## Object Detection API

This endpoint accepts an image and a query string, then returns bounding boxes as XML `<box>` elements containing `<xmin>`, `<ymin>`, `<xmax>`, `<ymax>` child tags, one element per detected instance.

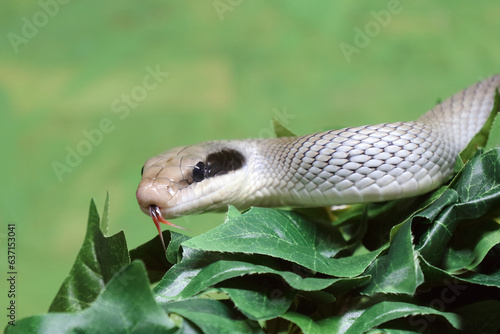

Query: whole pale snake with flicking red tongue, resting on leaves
<box><xmin>136</xmin><ymin>75</ymin><xmax>500</xmax><ymax>236</ymax></box>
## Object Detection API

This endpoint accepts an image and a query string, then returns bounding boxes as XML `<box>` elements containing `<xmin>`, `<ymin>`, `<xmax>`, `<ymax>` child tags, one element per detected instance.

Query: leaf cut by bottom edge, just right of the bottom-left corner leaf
<box><xmin>162</xmin><ymin>298</ymin><xmax>263</xmax><ymax>334</ymax></box>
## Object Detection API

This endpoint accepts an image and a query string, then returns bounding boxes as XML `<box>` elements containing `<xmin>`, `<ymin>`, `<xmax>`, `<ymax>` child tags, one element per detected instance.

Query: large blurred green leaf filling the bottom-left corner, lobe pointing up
<box><xmin>6</xmin><ymin>262</ymin><xmax>176</xmax><ymax>334</ymax></box>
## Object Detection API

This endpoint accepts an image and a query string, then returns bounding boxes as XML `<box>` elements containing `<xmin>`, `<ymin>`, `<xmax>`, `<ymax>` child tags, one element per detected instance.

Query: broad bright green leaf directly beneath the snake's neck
<box><xmin>183</xmin><ymin>208</ymin><xmax>383</xmax><ymax>277</ymax></box>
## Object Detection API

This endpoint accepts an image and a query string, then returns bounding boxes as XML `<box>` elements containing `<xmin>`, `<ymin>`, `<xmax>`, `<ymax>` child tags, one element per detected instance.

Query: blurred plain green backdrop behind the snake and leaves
<box><xmin>0</xmin><ymin>0</ymin><xmax>500</xmax><ymax>327</ymax></box>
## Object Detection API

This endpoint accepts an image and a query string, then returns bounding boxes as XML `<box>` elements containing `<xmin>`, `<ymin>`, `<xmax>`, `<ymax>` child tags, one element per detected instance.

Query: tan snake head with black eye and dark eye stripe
<box><xmin>136</xmin><ymin>142</ymin><xmax>246</xmax><ymax>218</ymax></box>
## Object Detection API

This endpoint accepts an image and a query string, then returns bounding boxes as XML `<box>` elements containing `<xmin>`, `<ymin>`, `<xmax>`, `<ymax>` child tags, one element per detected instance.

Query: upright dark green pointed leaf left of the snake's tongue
<box><xmin>49</xmin><ymin>196</ymin><xmax>130</xmax><ymax>312</ymax></box>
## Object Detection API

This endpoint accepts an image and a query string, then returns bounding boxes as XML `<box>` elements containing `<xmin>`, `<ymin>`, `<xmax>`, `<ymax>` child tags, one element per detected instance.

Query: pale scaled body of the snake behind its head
<box><xmin>241</xmin><ymin>76</ymin><xmax>500</xmax><ymax>207</ymax></box>
